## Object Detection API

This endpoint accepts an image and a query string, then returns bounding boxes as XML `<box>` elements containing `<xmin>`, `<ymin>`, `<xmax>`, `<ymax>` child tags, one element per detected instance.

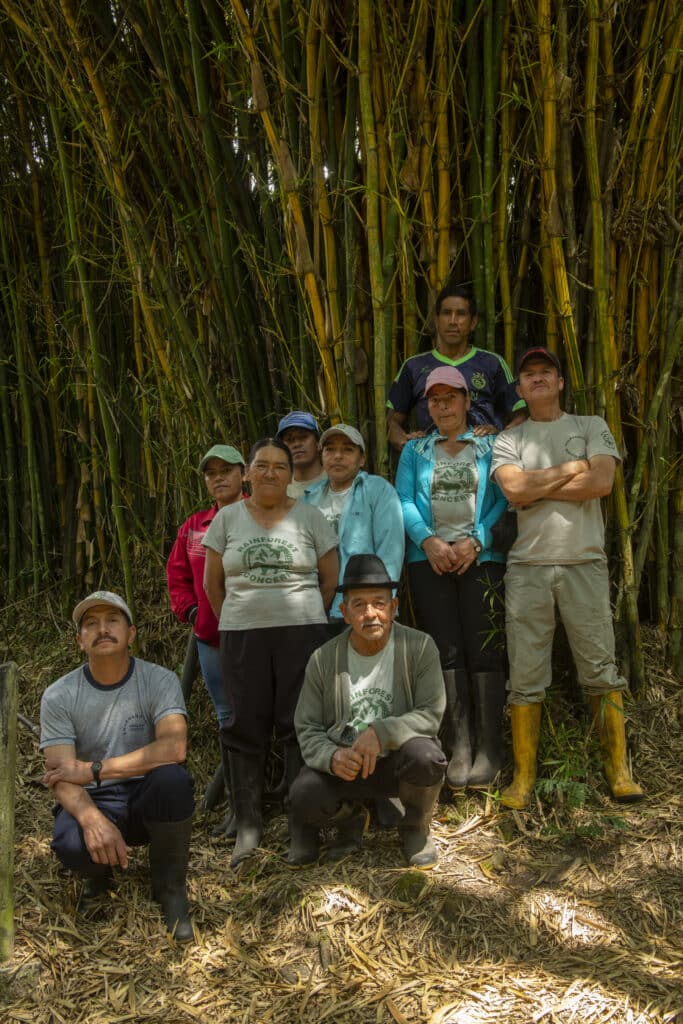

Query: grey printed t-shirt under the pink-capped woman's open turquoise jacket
<box><xmin>431</xmin><ymin>443</ymin><xmax>479</xmax><ymax>543</ymax></box>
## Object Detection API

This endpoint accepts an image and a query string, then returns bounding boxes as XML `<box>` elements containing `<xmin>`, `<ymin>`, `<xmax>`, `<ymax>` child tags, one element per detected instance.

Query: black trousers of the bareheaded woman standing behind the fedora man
<box><xmin>220</xmin><ymin>624</ymin><xmax>328</xmax><ymax>755</ymax></box>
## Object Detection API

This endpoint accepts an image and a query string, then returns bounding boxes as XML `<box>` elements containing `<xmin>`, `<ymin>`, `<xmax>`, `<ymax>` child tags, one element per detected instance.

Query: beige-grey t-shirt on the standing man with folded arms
<box><xmin>490</xmin><ymin>413</ymin><xmax>620</xmax><ymax>565</ymax></box>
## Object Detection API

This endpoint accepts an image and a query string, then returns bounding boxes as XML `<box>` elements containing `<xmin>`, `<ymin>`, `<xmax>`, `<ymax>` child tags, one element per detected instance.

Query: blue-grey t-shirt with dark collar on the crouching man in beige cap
<box><xmin>40</xmin><ymin>657</ymin><xmax>187</xmax><ymax>787</ymax></box>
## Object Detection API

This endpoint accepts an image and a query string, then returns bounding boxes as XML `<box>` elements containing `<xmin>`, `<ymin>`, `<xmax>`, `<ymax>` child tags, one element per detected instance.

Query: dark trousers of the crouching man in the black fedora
<box><xmin>290</xmin><ymin>736</ymin><xmax>446</xmax><ymax>826</ymax></box>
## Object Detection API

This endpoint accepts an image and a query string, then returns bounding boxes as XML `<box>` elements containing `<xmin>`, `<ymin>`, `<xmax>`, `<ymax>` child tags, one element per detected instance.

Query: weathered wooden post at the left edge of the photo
<box><xmin>0</xmin><ymin>662</ymin><xmax>18</xmax><ymax>961</ymax></box>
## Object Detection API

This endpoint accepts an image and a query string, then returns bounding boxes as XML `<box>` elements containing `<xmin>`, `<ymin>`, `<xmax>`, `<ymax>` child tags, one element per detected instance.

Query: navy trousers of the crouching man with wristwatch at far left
<box><xmin>51</xmin><ymin>765</ymin><xmax>195</xmax><ymax>878</ymax></box>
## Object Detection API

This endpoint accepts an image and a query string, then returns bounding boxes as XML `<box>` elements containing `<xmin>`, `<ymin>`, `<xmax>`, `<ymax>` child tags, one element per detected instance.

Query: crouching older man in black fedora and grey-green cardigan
<box><xmin>287</xmin><ymin>554</ymin><xmax>446</xmax><ymax>868</ymax></box>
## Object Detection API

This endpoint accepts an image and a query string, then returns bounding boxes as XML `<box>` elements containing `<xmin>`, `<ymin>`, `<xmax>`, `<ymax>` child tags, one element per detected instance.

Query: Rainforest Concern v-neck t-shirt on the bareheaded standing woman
<box><xmin>202</xmin><ymin>502</ymin><xmax>337</xmax><ymax>630</ymax></box>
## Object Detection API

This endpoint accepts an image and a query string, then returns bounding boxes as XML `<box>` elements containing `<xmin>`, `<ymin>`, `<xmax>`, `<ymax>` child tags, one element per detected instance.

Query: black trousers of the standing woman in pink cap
<box><xmin>408</xmin><ymin>561</ymin><xmax>505</xmax><ymax>675</ymax></box>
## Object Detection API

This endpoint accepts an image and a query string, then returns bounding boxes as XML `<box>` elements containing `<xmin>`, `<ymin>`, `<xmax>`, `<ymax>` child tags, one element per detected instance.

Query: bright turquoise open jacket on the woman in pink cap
<box><xmin>396</xmin><ymin>430</ymin><xmax>508</xmax><ymax>563</ymax></box>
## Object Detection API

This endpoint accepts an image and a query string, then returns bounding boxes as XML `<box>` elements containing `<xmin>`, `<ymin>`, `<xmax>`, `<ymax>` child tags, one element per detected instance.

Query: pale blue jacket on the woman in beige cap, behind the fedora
<box><xmin>301</xmin><ymin>469</ymin><xmax>405</xmax><ymax>618</ymax></box>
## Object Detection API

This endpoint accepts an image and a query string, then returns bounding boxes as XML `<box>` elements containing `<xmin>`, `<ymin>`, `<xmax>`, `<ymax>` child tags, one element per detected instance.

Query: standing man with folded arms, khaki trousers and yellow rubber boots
<box><xmin>492</xmin><ymin>347</ymin><xmax>643</xmax><ymax>809</ymax></box>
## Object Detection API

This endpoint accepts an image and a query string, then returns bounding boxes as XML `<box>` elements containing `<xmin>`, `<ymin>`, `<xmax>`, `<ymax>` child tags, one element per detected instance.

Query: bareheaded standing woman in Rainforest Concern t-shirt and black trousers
<box><xmin>202</xmin><ymin>437</ymin><xmax>339</xmax><ymax>867</ymax></box>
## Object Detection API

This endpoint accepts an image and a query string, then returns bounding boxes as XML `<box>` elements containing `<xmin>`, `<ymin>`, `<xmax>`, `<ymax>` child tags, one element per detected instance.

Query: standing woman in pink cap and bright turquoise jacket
<box><xmin>396</xmin><ymin>367</ymin><xmax>507</xmax><ymax>788</ymax></box>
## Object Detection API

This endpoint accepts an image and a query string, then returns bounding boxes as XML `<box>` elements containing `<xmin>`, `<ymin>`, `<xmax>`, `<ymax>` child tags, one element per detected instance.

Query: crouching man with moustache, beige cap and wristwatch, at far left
<box><xmin>40</xmin><ymin>591</ymin><xmax>195</xmax><ymax>942</ymax></box>
